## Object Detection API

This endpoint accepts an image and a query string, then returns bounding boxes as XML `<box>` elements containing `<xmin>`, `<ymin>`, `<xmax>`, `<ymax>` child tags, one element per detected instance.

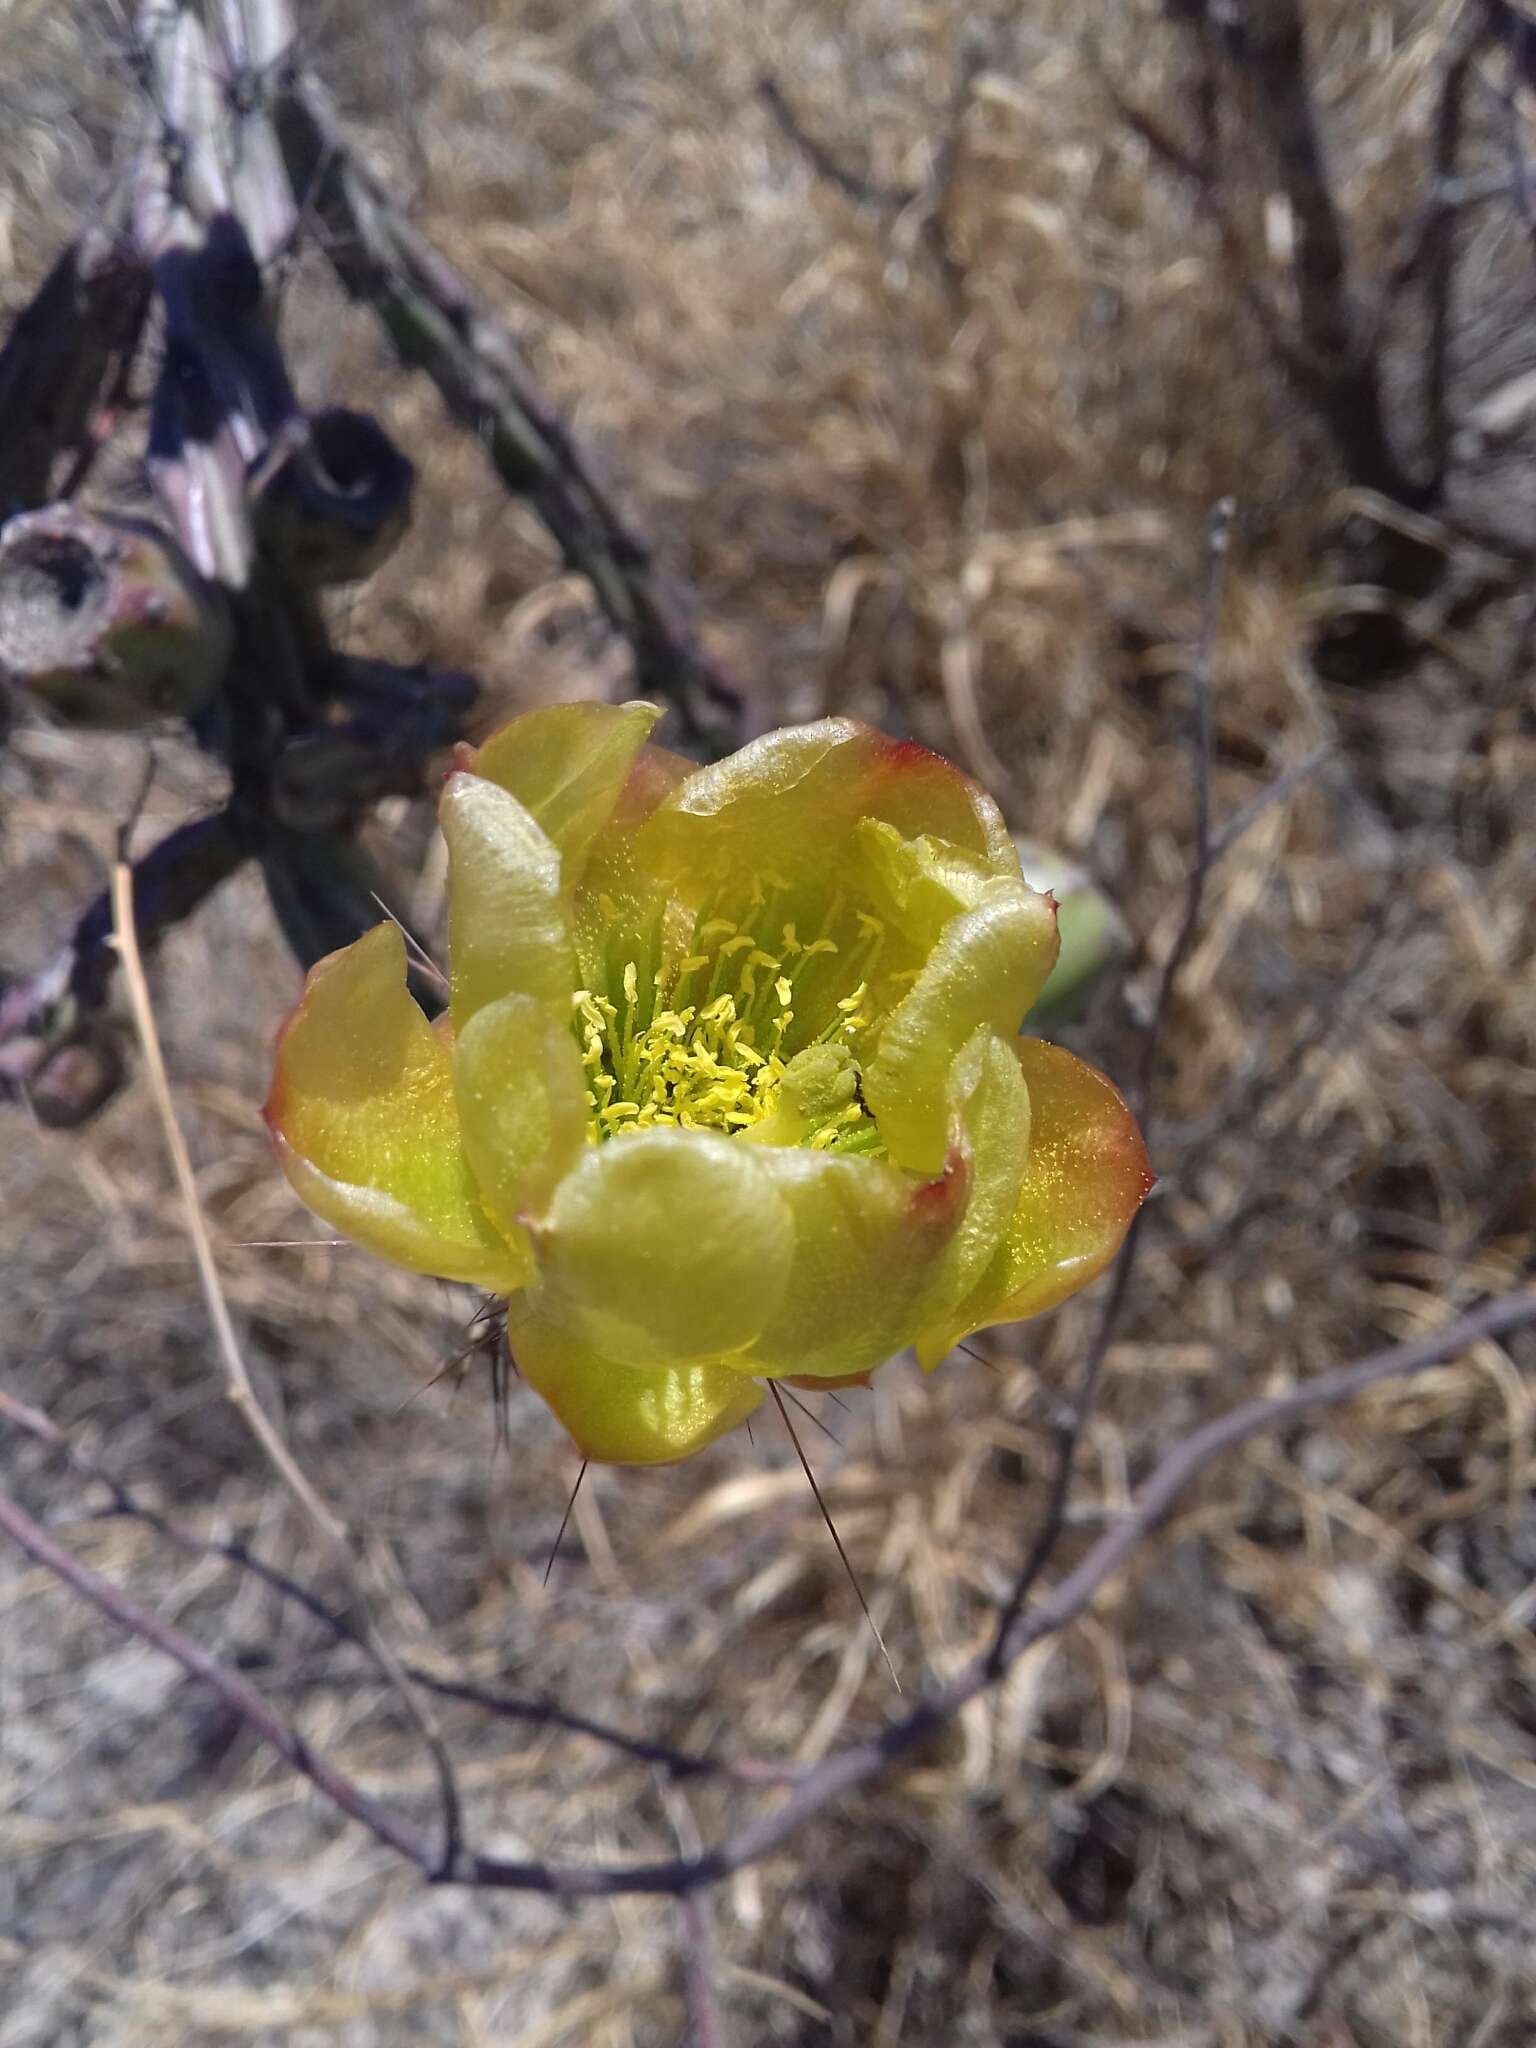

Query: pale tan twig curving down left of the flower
<box><xmin>113</xmin><ymin>858</ymin><xmax>461</xmax><ymax>1868</ymax></box>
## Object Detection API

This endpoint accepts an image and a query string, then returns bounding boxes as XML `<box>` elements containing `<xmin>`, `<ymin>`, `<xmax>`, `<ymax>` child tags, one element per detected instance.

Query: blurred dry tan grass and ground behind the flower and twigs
<box><xmin>0</xmin><ymin>0</ymin><xmax>1536</xmax><ymax>2048</ymax></box>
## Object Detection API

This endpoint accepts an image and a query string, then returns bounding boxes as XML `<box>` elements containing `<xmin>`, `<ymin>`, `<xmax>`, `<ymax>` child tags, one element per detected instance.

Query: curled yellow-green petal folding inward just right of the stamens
<box><xmin>864</xmin><ymin>881</ymin><xmax>1057</xmax><ymax>1176</ymax></box>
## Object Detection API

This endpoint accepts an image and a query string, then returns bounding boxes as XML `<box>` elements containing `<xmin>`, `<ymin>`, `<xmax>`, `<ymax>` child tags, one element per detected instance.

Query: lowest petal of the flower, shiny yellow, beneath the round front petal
<box><xmin>506</xmin><ymin>1300</ymin><xmax>762</xmax><ymax>1464</ymax></box>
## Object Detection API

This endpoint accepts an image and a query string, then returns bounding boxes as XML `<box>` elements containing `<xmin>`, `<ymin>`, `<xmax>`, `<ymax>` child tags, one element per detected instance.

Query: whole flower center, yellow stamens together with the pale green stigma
<box><xmin>573</xmin><ymin>885</ymin><xmax>885</xmax><ymax>1151</ymax></box>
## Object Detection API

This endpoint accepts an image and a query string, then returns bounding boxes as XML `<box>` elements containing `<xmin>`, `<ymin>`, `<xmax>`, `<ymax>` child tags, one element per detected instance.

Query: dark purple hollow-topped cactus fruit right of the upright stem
<box><xmin>256</xmin><ymin>406</ymin><xmax>416</xmax><ymax>590</ymax></box>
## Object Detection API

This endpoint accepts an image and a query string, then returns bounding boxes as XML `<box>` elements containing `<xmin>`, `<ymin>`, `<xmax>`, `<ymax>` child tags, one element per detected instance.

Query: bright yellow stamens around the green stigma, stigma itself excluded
<box><xmin>573</xmin><ymin>889</ymin><xmax>885</xmax><ymax>1151</ymax></box>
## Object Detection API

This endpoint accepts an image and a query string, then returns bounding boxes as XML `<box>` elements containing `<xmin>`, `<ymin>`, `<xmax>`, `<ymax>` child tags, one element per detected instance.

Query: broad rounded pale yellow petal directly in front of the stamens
<box><xmin>537</xmin><ymin>1126</ymin><xmax>795</xmax><ymax>1366</ymax></box>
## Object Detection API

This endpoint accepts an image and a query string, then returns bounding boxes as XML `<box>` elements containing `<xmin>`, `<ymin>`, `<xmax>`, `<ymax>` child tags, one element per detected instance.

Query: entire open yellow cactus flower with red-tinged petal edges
<box><xmin>266</xmin><ymin>705</ymin><xmax>1151</xmax><ymax>1464</ymax></box>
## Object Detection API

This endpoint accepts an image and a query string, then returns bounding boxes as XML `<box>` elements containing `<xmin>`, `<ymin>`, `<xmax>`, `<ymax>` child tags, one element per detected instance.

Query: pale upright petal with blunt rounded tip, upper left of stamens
<box><xmin>438</xmin><ymin>770</ymin><xmax>575</xmax><ymax>1030</ymax></box>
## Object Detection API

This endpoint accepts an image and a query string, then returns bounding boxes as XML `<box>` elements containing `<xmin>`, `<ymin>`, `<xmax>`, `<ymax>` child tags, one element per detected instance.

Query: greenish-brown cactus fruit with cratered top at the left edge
<box><xmin>0</xmin><ymin>506</ymin><xmax>231</xmax><ymax>729</ymax></box>
